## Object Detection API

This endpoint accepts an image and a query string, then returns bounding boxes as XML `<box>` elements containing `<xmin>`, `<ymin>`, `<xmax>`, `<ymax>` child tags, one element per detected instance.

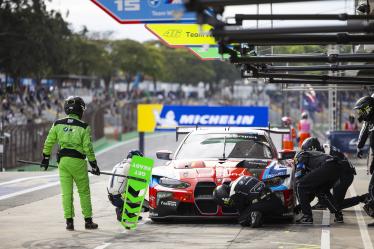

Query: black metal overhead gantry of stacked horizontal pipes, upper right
<box><xmin>184</xmin><ymin>0</ymin><xmax>374</xmax><ymax>130</ymax></box>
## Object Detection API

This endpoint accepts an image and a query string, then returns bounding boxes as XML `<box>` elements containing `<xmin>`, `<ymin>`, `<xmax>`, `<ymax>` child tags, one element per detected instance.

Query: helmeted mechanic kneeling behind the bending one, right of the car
<box><xmin>301</xmin><ymin>137</ymin><xmax>367</xmax><ymax>210</ymax></box>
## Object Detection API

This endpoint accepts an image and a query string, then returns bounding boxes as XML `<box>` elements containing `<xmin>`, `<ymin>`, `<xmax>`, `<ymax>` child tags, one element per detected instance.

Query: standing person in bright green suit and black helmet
<box><xmin>41</xmin><ymin>97</ymin><xmax>100</xmax><ymax>230</ymax></box>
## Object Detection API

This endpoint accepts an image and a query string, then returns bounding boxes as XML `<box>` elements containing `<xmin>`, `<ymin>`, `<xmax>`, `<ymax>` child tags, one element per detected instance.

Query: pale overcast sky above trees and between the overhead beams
<box><xmin>46</xmin><ymin>0</ymin><xmax>353</xmax><ymax>41</ymax></box>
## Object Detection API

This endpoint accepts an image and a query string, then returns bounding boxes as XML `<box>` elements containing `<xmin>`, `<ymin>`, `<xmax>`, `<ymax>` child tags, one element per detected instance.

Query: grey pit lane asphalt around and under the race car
<box><xmin>0</xmin><ymin>134</ymin><xmax>374</xmax><ymax>249</ymax></box>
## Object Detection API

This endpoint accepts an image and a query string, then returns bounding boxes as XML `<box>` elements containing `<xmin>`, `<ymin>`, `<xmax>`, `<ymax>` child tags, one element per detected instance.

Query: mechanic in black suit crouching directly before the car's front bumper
<box><xmin>213</xmin><ymin>176</ymin><xmax>285</xmax><ymax>227</ymax></box>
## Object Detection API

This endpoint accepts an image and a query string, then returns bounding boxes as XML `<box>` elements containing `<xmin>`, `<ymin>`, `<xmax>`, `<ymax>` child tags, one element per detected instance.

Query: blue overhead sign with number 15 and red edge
<box><xmin>91</xmin><ymin>0</ymin><xmax>196</xmax><ymax>24</ymax></box>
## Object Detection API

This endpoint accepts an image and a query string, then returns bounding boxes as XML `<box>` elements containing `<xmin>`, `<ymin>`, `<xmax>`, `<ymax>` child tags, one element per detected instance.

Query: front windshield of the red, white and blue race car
<box><xmin>176</xmin><ymin>134</ymin><xmax>272</xmax><ymax>159</ymax></box>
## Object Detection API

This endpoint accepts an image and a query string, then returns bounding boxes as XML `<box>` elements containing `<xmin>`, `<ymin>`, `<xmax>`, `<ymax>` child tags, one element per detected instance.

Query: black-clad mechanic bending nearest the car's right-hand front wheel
<box><xmin>294</xmin><ymin>151</ymin><xmax>343</xmax><ymax>224</ymax></box>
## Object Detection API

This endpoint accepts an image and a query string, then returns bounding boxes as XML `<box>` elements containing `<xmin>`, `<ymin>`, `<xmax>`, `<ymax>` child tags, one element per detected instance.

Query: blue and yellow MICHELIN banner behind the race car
<box><xmin>138</xmin><ymin>104</ymin><xmax>269</xmax><ymax>132</ymax></box>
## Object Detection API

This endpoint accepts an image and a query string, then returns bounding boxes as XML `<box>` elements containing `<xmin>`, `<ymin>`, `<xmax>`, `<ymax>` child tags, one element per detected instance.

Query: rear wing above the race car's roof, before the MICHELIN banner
<box><xmin>175</xmin><ymin>125</ymin><xmax>290</xmax><ymax>141</ymax></box>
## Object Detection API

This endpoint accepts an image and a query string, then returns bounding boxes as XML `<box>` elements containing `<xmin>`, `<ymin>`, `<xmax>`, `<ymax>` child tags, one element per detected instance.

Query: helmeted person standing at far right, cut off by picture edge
<box><xmin>353</xmin><ymin>96</ymin><xmax>374</xmax><ymax>226</ymax></box>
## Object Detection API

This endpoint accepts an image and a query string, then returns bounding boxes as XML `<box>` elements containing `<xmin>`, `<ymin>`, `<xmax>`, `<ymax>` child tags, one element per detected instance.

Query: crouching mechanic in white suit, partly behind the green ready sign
<box><xmin>107</xmin><ymin>150</ymin><xmax>143</xmax><ymax>221</ymax></box>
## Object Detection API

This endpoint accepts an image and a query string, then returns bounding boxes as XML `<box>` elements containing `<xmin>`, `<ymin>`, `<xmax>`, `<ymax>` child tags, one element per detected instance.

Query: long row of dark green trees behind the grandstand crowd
<box><xmin>0</xmin><ymin>0</ymin><xmax>240</xmax><ymax>91</ymax></box>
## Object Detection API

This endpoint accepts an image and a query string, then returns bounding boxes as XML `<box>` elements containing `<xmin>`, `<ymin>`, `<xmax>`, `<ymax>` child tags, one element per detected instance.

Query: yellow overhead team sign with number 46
<box><xmin>145</xmin><ymin>24</ymin><xmax>217</xmax><ymax>47</ymax></box>
